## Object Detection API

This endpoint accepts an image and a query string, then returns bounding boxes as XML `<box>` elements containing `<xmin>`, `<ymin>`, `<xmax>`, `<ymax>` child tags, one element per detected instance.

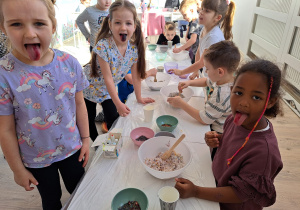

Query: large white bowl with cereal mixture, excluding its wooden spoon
<box><xmin>138</xmin><ymin>136</ymin><xmax>192</xmax><ymax>179</ymax></box>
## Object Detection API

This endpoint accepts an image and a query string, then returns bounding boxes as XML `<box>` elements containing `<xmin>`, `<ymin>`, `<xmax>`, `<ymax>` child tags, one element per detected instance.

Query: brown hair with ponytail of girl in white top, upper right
<box><xmin>202</xmin><ymin>0</ymin><xmax>235</xmax><ymax>40</ymax></box>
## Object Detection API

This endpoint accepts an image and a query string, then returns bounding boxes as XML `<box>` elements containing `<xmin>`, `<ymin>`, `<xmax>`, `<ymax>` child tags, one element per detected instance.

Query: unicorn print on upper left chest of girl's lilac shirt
<box><xmin>17</xmin><ymin>70</ymin><xmax>55</xmax><ymax>95</ymax></box>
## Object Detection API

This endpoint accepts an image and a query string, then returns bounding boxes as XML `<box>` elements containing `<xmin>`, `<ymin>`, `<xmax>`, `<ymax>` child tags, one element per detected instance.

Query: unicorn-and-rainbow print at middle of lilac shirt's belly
<box><xmin>28</xmin><ymin>106</ymin><xmax>63</xmax><ymax>130</ymax></box>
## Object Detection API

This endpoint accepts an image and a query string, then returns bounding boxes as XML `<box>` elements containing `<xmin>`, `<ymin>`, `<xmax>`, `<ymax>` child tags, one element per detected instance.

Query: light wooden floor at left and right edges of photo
<box><xmin>0</xmin><ymin>101</ymin><xmax>300</xmax><ymax>210</ymax></box>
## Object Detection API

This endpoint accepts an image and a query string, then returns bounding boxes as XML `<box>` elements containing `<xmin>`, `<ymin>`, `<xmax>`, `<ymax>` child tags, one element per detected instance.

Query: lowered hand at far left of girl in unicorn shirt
<box><xmin>14</xmin><ymin>168</ymin><xmax>39</xmax><ymax>191</ymax></box>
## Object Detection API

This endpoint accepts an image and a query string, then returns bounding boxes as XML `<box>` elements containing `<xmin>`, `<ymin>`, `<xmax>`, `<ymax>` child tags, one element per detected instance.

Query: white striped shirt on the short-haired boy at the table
<box><xmin>199</xmin><ymin>78</ymin><xmax>233</xmax><ymax>133</ymax></box>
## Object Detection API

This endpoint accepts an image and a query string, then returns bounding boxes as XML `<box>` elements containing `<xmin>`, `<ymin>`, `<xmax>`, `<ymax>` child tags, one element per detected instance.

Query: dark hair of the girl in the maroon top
<box><xmin>234</xmin><ymin>59</ymin><xmax>283</xmax><ymax>118</ymax></box>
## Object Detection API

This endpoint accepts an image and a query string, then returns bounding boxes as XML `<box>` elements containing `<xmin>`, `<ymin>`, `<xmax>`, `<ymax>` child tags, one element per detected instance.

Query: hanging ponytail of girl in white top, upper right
<box><xmin>221</xmin><ymin>1</ymin><xmax>235</xmax><ymax>40</ymax></box>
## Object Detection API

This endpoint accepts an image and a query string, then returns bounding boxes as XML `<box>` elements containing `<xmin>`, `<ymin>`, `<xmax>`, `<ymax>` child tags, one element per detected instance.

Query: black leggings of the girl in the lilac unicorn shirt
<box><xmin>27</xmin><ymin>150</ymin><xmax>84</xmax><ymax>210</ymax></box>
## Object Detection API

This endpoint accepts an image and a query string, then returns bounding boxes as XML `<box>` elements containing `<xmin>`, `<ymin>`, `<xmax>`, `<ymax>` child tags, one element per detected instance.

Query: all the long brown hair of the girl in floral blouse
<box><xmin>90</xmin><ymin>0</ymin><xmax>146</xmax><ymax>79</ymax></box>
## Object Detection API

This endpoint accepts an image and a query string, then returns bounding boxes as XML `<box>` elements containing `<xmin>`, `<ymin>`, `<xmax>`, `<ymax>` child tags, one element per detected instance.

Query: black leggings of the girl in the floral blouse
<box><xmin>84</xmin><ymin>99</ymin><xmax>119</xmax><ymax>141</ymax></box>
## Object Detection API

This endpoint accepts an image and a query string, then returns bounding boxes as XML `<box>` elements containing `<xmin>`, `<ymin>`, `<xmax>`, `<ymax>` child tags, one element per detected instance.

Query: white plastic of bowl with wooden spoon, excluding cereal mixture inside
<box><xmin>138</xmin><ymin>136</ymin><xmax>192</xmax><ymax>179</ymax></box>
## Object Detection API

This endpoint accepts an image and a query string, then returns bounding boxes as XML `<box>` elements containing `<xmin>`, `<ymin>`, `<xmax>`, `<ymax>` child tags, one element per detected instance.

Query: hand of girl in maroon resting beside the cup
<box><xmin>175</xmin><ymin>178</ymin><xmax>197</xmax><ymax>198</ymax></box>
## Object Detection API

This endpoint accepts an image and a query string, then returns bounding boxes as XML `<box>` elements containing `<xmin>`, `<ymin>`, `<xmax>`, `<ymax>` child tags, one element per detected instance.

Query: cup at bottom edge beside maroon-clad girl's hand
<box><xmin>158</xmin><ymin>186</ymin><xmax>179</xmax><ymax>210</ymax></box>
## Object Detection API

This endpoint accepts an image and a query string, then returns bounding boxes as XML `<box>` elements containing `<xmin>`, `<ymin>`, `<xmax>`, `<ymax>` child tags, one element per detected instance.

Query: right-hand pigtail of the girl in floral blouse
<box><xmin>133</xmin><ymin>19</ymin><xmax>146</xmax><ymax>79</ymax></box>
